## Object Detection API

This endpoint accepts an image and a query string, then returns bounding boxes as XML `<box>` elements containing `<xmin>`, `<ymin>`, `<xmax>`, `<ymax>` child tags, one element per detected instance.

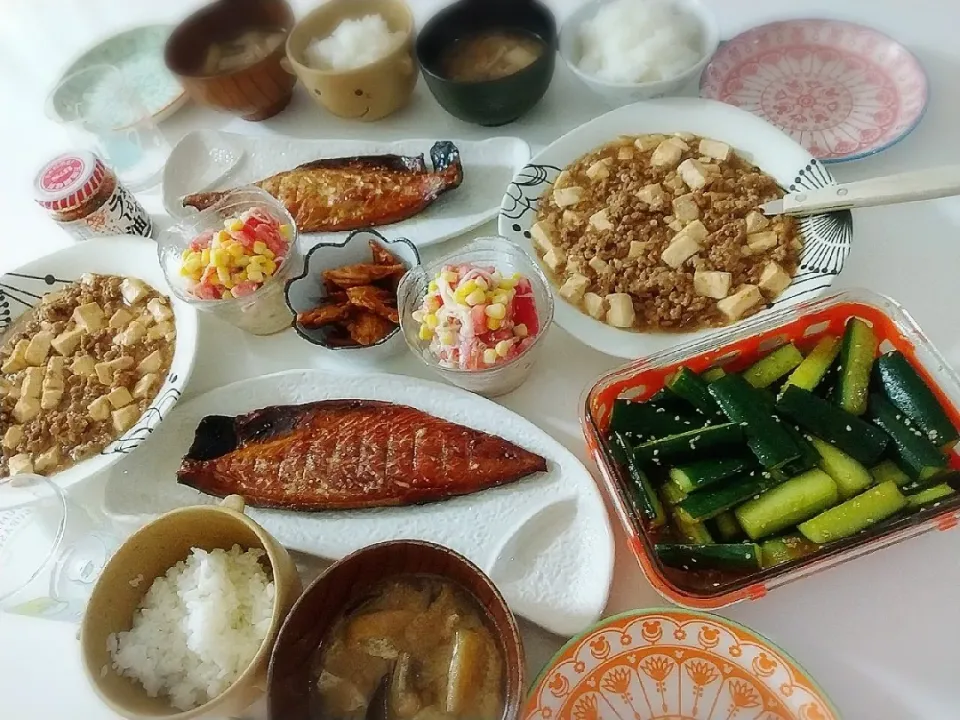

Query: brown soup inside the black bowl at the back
<box><xmin>440</xmin><ymin>30</ymin><xmax>544</xmax><ymax>82</ymax></box>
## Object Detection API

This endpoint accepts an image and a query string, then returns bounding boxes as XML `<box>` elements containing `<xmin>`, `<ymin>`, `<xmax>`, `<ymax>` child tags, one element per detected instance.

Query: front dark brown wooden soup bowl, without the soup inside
<box><xmin>267</xmin><ymin>540</ymin><xmax>526</xmax><ymax>720</ymax></box>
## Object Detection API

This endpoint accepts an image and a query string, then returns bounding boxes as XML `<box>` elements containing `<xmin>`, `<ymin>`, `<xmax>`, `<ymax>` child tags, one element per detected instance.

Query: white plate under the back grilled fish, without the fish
<box><xmin>163</xmin><ymin>130</ymin><xmax>530</xmax><ymax>247</ymax></box>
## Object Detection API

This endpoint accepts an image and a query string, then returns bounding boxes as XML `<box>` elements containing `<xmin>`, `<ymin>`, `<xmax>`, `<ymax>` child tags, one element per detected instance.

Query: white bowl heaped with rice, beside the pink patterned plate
<box><xmin>559</xmin><ymin>0</ymin><xmax>720</xmax><ymax>107</ymax></box>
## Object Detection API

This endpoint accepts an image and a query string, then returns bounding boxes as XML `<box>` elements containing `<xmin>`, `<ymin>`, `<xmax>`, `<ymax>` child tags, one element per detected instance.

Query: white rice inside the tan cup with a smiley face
<box><xmin>304</xmin><ymin>15</ymin><xmax>403</xmax><ymax>70</ymax></box>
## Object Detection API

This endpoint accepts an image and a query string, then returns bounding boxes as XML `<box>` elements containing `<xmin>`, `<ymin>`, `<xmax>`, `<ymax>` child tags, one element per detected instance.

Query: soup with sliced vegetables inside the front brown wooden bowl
<box><xmin>316</xmin><ymin>575</ymin><xmax>504</xmax><ymax>720</ymax></box>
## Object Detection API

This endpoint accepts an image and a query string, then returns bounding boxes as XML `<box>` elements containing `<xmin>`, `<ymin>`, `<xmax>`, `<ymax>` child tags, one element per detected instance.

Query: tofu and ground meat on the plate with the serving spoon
<box><xmin>531</xmin><ymin>133</ymin><xmax>802</xmax><ymax>332</ymax></box>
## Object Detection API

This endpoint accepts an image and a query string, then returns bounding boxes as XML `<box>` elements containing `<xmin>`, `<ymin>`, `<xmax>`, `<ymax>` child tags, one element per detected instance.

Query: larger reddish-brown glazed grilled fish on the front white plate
<box><xmin>177</xmin><ymin>400</ymin><xmax>547</xmax><ymax>510</ymax></box>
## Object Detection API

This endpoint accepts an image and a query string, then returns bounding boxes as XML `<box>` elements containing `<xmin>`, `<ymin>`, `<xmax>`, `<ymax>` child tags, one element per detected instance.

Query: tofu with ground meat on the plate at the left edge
<box><xmin>0</xmin><ymin>275</ymin><xmax>176</xmax><ymax>478</ymax></box>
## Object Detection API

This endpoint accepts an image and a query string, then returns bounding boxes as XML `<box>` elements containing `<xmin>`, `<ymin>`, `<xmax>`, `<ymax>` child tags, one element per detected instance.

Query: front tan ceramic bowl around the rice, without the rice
<box><xmin>80</xmin><ymin>495</ymin><xmax>302</xmax><ymax>720</ymax></box>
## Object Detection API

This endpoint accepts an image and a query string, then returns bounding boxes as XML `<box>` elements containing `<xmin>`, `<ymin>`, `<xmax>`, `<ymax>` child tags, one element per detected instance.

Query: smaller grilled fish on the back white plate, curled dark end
<box><xmin>183</xmin><ymin>142</ymin><xmax>463</xmax><ymax>232</ymax></box>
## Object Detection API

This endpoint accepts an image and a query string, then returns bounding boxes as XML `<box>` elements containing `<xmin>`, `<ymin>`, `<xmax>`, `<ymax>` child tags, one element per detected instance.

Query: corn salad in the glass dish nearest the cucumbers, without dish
<box><xmin>412</xmin><ymin>265</ymin><xmax>540</xmax><ymax>370</ymax></box>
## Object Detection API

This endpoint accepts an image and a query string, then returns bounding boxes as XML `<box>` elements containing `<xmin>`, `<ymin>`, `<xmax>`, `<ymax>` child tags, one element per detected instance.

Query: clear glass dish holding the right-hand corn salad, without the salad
<box><xmin>397</xmin><ymin>236</ymin><xmax>553</xmax><ymax>397</ymax></box>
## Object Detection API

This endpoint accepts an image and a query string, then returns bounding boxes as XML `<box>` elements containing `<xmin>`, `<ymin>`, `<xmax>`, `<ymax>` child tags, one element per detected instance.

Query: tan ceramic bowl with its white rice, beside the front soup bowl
<box><xmin>80</xmin><ymin>496</ymin><xmax>302</xmax><ymax>720</ymax></box>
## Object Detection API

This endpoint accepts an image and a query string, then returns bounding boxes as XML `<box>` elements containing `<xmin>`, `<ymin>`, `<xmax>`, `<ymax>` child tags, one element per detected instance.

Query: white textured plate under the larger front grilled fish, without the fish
<box><xmin>104</xmin><ymin>370</ymin><xmax>614</xmax><ymax>635</ymax></box>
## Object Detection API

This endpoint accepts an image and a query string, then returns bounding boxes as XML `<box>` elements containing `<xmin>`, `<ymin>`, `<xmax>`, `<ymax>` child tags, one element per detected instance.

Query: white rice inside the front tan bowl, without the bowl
<box><xmin>107</xmin><ymin>545</ymin><xmax>276</xmax><ymax>710</ymax></box>
